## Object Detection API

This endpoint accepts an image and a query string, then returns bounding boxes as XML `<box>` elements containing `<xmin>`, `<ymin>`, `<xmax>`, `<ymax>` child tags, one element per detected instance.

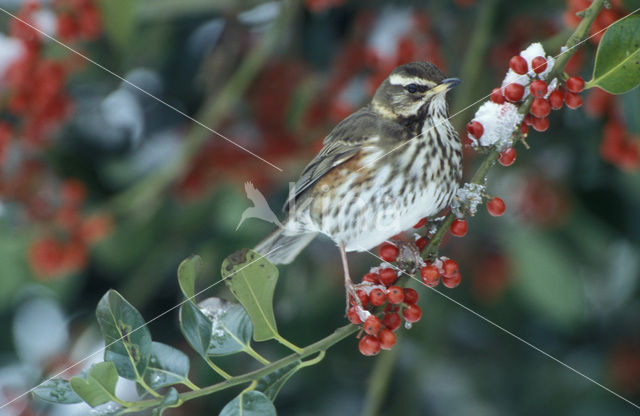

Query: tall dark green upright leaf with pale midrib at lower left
<box><xmin>96</xmin><ymin>290</ymin><xmax>151</xmax><ymax>380</ymax></box>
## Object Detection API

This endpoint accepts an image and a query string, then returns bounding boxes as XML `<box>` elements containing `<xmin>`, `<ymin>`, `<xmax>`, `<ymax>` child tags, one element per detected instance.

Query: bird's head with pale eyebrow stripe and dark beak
<box><xmin>372</xmin><ymin>62</ymin><xmax>460</xmax><ymax>119</ymax></box>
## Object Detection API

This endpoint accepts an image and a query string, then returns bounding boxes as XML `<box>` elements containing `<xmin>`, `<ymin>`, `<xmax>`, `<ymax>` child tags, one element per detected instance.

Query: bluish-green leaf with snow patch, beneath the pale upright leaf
<box><xmin>198</xmin><ymin>298</ymin><xmax>253</xmax><ymax>355</ymax></box>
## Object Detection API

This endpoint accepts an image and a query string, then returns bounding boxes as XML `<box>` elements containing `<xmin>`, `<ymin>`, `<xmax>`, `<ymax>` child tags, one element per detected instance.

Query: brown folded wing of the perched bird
<box><xmin>283</xmin><ymin>107</ymin><xmax>407</xmax><ymax>212</ymax></box>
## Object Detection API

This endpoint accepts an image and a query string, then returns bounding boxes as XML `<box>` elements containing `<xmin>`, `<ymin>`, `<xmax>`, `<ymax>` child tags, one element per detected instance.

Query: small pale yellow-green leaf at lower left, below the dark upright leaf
<box><xmin>69</xmin><ymin>361</ymin><xmax>118</xmax><ymax>407</ymax></box>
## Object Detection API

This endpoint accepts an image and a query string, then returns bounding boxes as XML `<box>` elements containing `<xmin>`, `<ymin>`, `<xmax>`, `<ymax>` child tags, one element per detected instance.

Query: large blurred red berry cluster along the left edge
<box><xmin>0</xmin><ymin>0</ymin><xmax>111</xmax><ymax>279</ymax></box>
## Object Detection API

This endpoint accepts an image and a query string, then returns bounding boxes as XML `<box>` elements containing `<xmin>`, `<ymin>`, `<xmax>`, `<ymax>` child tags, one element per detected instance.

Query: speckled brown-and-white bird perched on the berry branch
<box><xmin>254</xmin><ymin>61</ymin><xmax>462</xmax><ymax>307</ymax></box>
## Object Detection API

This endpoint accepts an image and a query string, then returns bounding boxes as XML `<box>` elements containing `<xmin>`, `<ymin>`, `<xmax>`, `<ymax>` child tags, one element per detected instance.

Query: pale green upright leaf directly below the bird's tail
<box><xmin>222</xmin><ymin>249</ymin><xmax>278</xmax><ymax>341</ymax></box>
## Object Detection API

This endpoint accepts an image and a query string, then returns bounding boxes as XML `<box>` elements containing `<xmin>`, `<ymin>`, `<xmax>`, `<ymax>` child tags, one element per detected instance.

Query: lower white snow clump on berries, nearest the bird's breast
<box><xmin>473</xmin><ymin>101</ymin><xmax>524</xmax><ymax>150</ymax></box>
